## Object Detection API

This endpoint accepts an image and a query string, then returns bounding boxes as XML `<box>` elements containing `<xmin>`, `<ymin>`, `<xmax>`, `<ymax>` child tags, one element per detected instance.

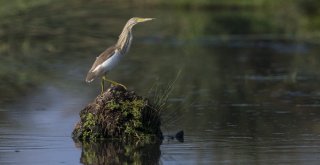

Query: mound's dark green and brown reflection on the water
<box><xmin>75</xmin><ymin>141</ymin><xmax>161</xmax><ymax>165</ymax></box>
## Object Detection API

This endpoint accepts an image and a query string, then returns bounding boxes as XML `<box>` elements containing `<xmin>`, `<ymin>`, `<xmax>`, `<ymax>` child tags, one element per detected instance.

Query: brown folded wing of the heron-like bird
<box><xmin>86</xmin><ymin>46</ymin><xmax>117</xmax><ymax>82</ymax></box>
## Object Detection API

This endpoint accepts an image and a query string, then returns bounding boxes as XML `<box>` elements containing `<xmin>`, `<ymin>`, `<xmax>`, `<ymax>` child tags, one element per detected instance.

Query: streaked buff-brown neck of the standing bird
<box><xmin>116</xmin><ymin>27</ymin><xmax>132</xmax><ymax>54</ymax></box>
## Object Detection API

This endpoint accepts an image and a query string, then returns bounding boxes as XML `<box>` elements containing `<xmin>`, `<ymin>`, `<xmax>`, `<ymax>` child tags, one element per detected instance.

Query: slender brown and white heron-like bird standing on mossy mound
<box><xmin>86</xmin><ymin>17</ymin><xmax>155</xmax><ymax>93</ymax></box>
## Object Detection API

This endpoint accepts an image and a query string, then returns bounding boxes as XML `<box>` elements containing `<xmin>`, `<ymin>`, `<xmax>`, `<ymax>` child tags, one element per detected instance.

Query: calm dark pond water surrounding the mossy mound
<box><xmin>0</xmin><ymin>1</ymin><xmax>320</xmax><ymax>164</ymax></box>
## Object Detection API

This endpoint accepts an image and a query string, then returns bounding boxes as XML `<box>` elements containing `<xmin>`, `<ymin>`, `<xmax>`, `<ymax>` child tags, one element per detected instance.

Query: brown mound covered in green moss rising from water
<box><xmin>72</xmin><ymin>86</ymin><xmax>162</xmax><ymax>143</ymax></box>
